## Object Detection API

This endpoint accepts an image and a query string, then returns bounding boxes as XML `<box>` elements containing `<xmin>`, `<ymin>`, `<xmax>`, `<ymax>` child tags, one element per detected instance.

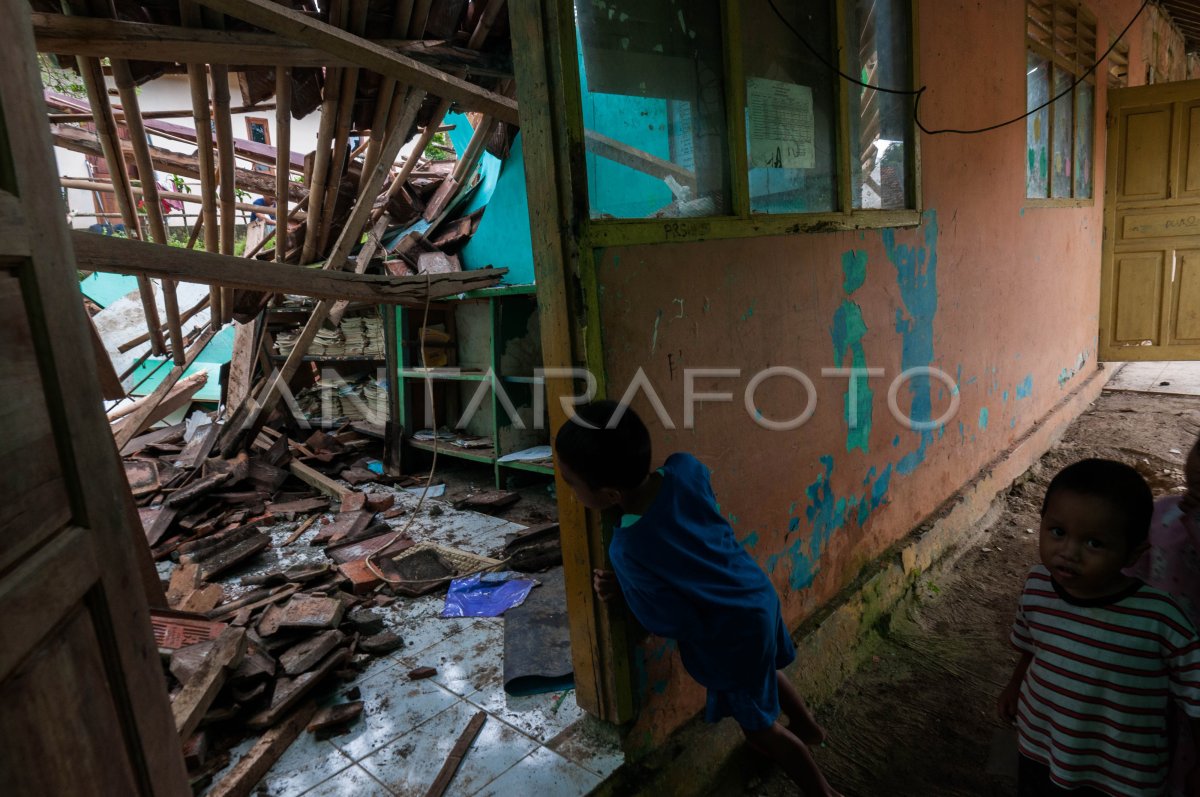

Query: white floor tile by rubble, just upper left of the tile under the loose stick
<box><xmin>330</xmin><ymin>665</ymin><xmax>456</xmax><ymax>761</ymax></box>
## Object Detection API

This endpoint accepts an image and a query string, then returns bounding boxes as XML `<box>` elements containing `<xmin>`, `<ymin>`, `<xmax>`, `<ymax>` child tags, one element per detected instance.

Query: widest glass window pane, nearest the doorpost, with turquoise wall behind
<box><xmin>575</xmin><ymin>0</ymin><xmax>730</xmax><ymax>218</ymax></box>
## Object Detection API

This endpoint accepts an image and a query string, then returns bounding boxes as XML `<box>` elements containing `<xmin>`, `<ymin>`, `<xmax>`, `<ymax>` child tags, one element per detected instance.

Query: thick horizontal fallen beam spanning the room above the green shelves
<box><xmin>71</xmin><ymin>230</ymin><xmax>508</xmax><ymax>306</ymax></box>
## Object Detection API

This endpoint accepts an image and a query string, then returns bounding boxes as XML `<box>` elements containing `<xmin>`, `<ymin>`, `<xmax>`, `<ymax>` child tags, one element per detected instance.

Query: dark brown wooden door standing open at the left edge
<box><xmin>0</xmin><ymin>7</ymin><xmax>190</xmax><ymax>797</ymax></box>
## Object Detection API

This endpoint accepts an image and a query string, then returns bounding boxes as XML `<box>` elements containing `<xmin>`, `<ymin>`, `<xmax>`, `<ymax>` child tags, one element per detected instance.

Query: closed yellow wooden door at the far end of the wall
<box><xmin>1100</xmin><ymin>80</ymin><xmax>1200</xmax><ymax>360</ymax></box>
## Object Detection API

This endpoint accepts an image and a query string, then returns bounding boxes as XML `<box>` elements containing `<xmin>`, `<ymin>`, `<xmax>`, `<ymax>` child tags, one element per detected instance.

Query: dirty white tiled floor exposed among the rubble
<box><xmin>200</xmin><ymin>484</ymin><xmax>624</xmax><ymax>797</ymax></box>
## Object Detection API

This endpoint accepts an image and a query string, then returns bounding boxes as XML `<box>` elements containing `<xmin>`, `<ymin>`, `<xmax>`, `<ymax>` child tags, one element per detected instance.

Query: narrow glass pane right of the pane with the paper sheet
<box><xmin>844</xmin><ymin>0</ymin><xmax>914</xmax><ymax>209</ymax></box>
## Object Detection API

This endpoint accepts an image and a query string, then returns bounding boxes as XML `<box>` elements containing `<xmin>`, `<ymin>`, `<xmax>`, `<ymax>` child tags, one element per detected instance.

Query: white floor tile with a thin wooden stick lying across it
<box><xmin>359</xmin><ymin>701</ymin><xmax>538</xmax><ymax>797</ymax></box>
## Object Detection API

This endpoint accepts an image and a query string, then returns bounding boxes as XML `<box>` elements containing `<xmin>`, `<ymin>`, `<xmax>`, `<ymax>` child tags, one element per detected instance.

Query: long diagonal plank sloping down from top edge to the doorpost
<box><xmin>189</xmin><ymin>0</ymin><xmax>518</xmax><ymax>125</ymax></box>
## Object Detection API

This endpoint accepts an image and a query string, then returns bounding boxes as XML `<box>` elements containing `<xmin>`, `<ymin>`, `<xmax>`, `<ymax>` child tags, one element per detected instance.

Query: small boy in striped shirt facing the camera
<box><xmin>1000</xmin><ymin>460</ymin><xmax>1200</xmax><ymax>797</ymax></box>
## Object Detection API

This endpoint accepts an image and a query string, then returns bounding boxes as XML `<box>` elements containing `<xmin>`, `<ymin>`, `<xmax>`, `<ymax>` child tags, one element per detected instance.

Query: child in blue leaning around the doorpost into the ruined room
<box><xmin>554</xmin><ymin>401</ymin><xmax>838</xmax><ymax>797</ymax></box>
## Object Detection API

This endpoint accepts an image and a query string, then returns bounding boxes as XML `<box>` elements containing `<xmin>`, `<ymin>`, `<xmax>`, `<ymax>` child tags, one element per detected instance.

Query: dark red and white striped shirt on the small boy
<box><xmin>1012</xmin><ymin>565</ymin><xmax>1200</xmax><ymax>797</ymax></box>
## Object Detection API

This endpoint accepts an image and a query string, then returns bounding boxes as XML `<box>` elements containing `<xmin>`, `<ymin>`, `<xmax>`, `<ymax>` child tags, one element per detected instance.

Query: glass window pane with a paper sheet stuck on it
<box><xmin>742</xmin><ymin>0</ymin><xmax>838</xmax><ymax>214</ymax></box>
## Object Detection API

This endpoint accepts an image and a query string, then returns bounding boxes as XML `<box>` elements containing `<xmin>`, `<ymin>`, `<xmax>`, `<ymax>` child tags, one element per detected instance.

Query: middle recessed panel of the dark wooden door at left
<box><xmin>0</xmin><ymin>269</ymin><xmax>71</xmax><ymax>570</ymax></box>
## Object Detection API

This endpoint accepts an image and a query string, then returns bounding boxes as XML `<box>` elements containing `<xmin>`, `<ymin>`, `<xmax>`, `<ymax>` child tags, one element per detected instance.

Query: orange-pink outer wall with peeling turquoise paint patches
<box><xmin>598</xmin><ymin>0</ymin><xmax>1145</xmax><ymax>749</ymax></box>
